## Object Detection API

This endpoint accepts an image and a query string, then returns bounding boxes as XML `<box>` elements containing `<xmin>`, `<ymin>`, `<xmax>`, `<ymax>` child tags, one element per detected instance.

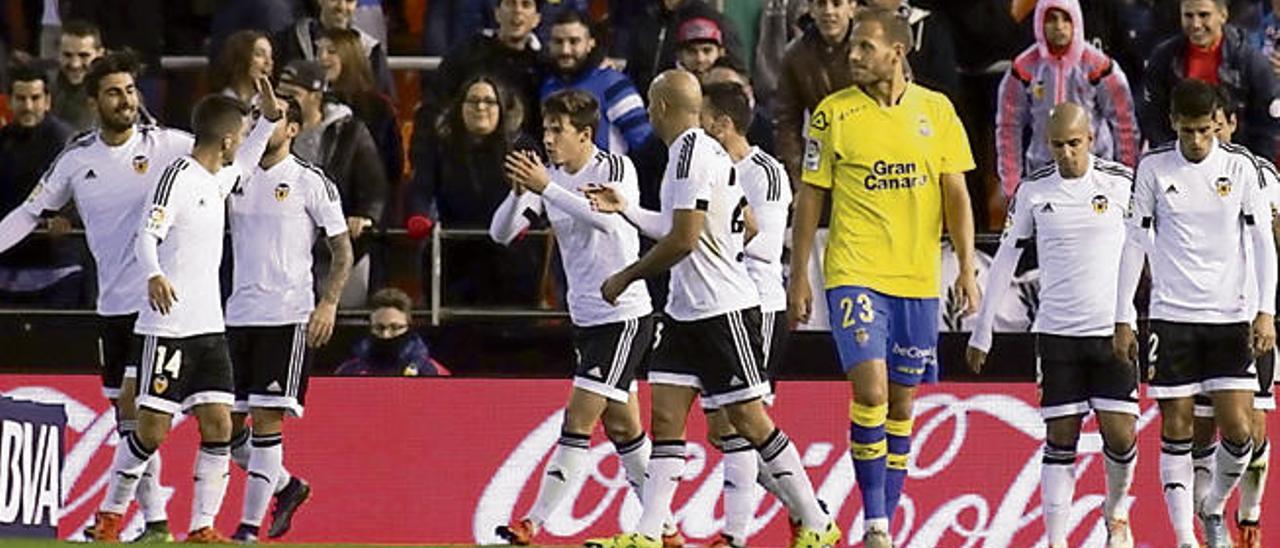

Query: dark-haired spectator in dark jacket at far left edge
<box><xmin>0</xmin><ymin>67</ymin><xmax>83</xmax><ymax>309</ymax></box>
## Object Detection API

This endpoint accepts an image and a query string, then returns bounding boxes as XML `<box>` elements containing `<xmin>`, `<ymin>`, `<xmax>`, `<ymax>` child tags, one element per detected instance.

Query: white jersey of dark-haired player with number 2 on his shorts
<box><xmin>1130</xmin><ymin>142</ymin><xmax>1274</xmax><ymax>324</ymax></box>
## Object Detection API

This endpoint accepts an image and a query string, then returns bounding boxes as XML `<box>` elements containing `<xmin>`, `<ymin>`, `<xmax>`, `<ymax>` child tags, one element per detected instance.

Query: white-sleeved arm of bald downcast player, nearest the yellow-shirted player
<box><xmin>965</xmin><ymin>186</ymin><xmax>1036</xmax><ymax>373</ymax></box>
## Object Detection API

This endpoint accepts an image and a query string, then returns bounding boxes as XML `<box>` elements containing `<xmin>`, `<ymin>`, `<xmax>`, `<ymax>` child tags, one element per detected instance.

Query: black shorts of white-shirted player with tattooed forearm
<box><xmin>227</xmin><ymin>324</ymin><xmax>314</xmax><ymax>416</ymax></box>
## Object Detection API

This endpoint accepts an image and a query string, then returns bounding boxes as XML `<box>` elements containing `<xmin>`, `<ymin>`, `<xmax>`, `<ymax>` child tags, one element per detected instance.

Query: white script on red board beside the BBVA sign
<box><xmin>4</xmin><ymin>387</ymin><xmax>183</xmax><ymax>539</ymax></box>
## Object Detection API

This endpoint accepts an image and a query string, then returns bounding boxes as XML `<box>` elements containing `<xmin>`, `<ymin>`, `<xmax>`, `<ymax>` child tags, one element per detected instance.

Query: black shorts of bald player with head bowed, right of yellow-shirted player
<box><xmin>1036</xmin><ymin>334</ymin><xmax>1138</xmax><ymax>420</ymax></box>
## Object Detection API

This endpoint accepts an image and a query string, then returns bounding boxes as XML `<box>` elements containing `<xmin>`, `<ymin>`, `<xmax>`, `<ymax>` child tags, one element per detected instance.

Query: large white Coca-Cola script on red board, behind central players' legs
<box><xmin>472</xmin><ymin>393</ymin><xmax>1156</xmax><ymax>548</ymax></box>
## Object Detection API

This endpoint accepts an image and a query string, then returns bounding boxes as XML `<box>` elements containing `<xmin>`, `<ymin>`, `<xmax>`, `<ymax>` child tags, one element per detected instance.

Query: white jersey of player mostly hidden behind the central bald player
<box><xmin>733</xmin><ymin>146</ymin><xmax>791</xmax><ymax>312</ymax></box>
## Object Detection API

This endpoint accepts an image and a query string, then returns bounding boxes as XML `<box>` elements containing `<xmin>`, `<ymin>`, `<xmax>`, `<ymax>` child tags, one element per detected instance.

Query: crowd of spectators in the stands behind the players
<box><xmin>0</xmin><ymin>0</ymin><xmax>1280</xmax><ymax>330</ymax></box>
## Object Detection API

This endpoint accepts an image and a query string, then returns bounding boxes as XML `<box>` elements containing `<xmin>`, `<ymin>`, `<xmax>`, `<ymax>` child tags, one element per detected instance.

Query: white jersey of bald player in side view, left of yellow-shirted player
<box><xmin>660</xmin><ymin>128</ymin><xmax>760</xmax><ymax>321</ymax></box>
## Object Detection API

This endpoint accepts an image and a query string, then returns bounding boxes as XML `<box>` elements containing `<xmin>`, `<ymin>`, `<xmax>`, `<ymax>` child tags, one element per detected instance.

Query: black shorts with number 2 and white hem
<box><xmin>1147</xmin><ymin>320</ymin><xmax>1258</xmax><ymax>399</ymax></box>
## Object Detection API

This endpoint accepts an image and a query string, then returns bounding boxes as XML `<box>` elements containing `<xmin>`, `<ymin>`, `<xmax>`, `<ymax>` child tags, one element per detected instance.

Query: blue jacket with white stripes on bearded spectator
<box><xmin>538</xmin><ymin>55</ymin><xmax>653</xmax><ymax>154</ymax></box>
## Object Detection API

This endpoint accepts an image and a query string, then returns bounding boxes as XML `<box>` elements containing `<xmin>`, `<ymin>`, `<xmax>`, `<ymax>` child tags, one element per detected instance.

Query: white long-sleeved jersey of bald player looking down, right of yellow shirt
<box><xmin>970</xmin><ymin>156</ymin><xmax>1133</xmax><ymax>351</ymax></box>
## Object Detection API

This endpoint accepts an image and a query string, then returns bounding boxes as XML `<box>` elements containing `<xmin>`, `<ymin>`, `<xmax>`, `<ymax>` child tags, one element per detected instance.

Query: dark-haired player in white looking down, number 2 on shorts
<box><xmin>1115</xmin><ymin>79</ymin><xmax>1276</xmax><ymax>548</ymax></box>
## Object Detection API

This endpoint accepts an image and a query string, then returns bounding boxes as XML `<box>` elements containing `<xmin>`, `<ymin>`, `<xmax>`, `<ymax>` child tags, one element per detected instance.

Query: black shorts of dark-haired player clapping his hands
<box><xmin>573</xmin><ymin>316</ymin><xmax>655</xmax><ymax>403</ymax></box>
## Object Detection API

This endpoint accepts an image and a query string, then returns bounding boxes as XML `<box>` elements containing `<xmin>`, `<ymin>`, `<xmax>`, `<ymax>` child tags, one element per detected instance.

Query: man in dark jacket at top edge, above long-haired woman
<box><xmin>271</xmin><ymin>0</ymin><xmax>396</xmax><ymax>96</ymax></box>
